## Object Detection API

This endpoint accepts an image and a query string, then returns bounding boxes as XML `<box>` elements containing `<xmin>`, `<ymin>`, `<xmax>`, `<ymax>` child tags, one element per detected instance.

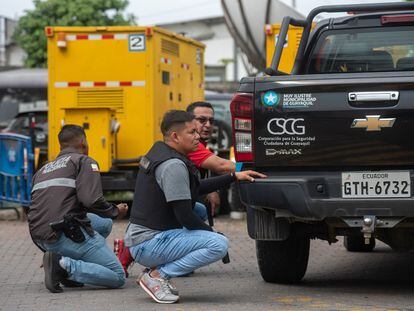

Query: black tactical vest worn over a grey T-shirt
<box><xmin>130</xmin><ymin>141</ymin><xmax>200</xmax><ymax>231</ymax></box>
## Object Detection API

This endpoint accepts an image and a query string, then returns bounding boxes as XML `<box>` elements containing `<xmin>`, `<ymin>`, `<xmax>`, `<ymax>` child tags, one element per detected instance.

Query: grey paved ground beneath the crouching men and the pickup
<box><xmin>0</xmin><ymin>219</ymin><xmax>414</xmax><ymax>311</ymax></box>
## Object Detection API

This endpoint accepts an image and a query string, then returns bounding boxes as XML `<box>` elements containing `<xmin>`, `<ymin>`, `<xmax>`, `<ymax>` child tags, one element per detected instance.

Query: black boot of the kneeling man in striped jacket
<box><xmin>43</xmin><ymin>252</ymin><xmax>68</xmax><ymax>293</ymax></box>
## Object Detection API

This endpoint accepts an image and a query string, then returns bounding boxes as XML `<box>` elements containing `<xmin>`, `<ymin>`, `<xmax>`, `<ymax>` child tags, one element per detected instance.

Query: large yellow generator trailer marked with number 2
<box><xmin>45</xmin><ymin>26</ymin><xmax>204</xmax><ymax>190</ymax></box>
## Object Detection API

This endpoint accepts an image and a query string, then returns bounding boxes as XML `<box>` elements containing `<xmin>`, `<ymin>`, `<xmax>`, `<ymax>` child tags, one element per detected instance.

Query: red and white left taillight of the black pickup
<box><xmin>230</xmin><ymin>93</ymin><xmax>253</xmax><ymax>162</ymax></box>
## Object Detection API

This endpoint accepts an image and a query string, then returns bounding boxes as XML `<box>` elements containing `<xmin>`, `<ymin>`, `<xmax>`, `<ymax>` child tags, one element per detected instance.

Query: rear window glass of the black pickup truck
<box><xmin>307</xmin><ymin>27</ymin><xmax>414</xmax><ymax>73</ymax></box>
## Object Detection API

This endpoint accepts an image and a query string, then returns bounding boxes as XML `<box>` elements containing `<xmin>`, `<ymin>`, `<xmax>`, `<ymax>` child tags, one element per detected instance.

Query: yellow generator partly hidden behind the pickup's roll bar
<box><xmin>265</xmin><ymin>24</ymin><xmax>303</xmax><ymax>73</ymax></box>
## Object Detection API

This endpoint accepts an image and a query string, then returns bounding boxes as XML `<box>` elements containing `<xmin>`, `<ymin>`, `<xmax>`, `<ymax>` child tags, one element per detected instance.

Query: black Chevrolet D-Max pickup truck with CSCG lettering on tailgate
<box><xmin>231</xmin><ymin>2</ymin><xmax>414</xmax><ymax>283</ymax></box>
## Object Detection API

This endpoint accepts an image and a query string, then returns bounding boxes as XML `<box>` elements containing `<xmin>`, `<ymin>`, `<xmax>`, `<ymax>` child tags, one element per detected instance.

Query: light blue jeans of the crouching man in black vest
<box><xmin>129</xmin><ymin>228</ymin><xmax>228</xmax><ymax>279</ymax></box>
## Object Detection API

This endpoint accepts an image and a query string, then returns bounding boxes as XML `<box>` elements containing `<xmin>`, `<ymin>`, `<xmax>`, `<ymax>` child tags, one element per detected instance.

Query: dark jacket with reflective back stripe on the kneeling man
<box><xmin>28</xmin><ymin>148</ymin><xmax>118</xmax><ymax>242</ymax></box>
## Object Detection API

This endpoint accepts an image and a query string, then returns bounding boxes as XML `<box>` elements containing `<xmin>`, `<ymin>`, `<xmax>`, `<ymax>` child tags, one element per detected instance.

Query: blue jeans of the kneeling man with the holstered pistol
<box><xmin>41</xmin><ymin>214</ymin><xmax>125</xmax><ymax>288</ymax></box>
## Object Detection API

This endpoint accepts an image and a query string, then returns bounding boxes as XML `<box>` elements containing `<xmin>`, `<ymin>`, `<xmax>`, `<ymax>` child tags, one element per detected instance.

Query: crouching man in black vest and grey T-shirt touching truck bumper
<box><xmin>125</xmin><ymin>110</ymin><xmax>266</xmax><ymax>303</ymax></box>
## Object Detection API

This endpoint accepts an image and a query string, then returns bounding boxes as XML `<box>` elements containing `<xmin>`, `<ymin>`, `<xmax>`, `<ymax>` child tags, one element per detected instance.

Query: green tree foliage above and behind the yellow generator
<box><xmin>14</xmin><ymin>0</ymin><xmax>135</xmax><ymax>68</ymax></box>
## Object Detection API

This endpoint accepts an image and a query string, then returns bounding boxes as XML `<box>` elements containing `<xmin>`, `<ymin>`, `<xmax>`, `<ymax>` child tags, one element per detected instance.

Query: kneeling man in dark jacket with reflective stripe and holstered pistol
<box><xmin>28</xmin><ymin>125</ymin><xmax>128</xmax><ymax>293</ymax></box>
